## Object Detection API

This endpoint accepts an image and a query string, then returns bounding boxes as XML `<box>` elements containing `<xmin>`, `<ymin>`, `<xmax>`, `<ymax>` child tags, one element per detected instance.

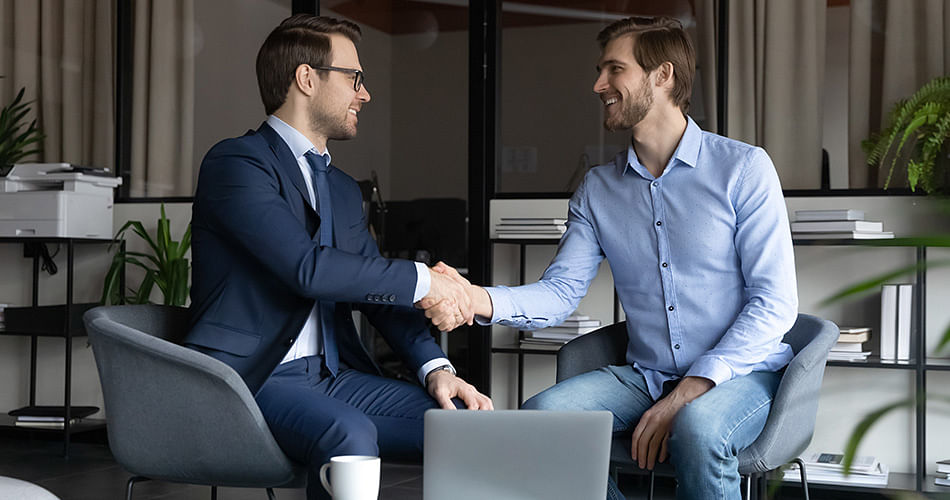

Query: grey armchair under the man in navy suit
<box><xmin>83</xmin><ymin>305</ymin><xmax>307</xmax><ymax>499</ymax></box>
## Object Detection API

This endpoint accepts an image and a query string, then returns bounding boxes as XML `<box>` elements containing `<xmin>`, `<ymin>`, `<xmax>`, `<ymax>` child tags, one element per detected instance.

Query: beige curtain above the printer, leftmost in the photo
<box><xmin>0</xmin><ymin>0</ymin><xmax>115</xmax><ymax>168</ymax></box>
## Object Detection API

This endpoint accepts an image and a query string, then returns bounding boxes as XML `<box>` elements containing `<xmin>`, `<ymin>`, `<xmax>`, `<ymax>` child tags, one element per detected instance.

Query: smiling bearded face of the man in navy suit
<box><xmin>309</xmin><ymin>33</ymin><xmax>370</xmax><ymax>140</ymax></box>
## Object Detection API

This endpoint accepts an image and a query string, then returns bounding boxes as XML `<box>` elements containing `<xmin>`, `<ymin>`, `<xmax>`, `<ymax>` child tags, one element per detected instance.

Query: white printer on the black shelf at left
<box><xmin>0</xmin><ymin>163</ymin><xmax>122</xmax><ymax>238</ymax></box>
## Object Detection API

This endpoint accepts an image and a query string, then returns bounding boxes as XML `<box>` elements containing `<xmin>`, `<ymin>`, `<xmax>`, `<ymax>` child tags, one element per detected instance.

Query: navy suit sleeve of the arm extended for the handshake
<box><xmin>193</xmin><ymin>140</ymin><xmax>416</xmax><ymax>306</ymax></box>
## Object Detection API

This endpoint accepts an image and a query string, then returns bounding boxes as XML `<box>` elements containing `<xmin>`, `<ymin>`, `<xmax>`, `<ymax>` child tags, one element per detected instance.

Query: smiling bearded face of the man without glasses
<box><xmin>594</xmin><ymin>35</ymin><xmax>654</xmax><ymax>131</ymax></box>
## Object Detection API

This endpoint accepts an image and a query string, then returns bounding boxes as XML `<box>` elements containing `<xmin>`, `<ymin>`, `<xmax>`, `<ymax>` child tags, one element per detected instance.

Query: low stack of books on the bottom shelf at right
<box><xmin>782</xmin><ymin>453</ymin><xmax>888</xmax><ymax>486</ymax></box>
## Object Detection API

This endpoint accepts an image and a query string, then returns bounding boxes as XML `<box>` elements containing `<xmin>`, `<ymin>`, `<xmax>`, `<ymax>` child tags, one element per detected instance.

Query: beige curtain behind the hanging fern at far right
<box><xmin>848</xmin><ymin>0</ymin><xmax>950</xmax><ymax>188</ymax></box>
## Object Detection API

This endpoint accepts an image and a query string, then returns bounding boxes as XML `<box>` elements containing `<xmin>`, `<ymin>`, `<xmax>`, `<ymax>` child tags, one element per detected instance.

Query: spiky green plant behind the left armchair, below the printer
<box><xmin>101</xmin><ymin>203</ymin><xmax>191</xmax><ymax>306</ymax></box>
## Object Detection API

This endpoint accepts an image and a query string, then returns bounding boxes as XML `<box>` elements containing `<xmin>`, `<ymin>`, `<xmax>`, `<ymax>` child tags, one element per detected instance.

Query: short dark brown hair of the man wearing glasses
<box><xmin>257</xmin><ymin>14</ymin><xmax>362</xmax><ymax>115</ymax></box>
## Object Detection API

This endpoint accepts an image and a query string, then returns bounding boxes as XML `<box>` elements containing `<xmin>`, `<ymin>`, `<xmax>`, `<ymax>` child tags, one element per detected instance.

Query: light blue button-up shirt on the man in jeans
<box><xmin>488</xmin><ymin>119</ymin><xmax>798</xmax><ymax>399</ymax></box>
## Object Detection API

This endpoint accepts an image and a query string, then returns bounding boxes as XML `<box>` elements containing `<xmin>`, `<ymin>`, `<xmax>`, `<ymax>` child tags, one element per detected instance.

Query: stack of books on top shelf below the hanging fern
<box><xmin>792</xmin><ymin>209</ymin><xmax>894</xmax><ymax>240</ymax></box>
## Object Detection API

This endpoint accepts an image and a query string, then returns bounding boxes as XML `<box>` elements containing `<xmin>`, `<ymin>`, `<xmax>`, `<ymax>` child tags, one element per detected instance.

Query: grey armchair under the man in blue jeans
<box><xmin>557</xmin><ymin>314</ymin><xmax>838</xmax><ymax>500</ymax></box>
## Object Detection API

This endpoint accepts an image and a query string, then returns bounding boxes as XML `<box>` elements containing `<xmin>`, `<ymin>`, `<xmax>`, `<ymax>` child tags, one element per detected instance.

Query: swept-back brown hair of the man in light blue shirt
<box><xmin>597</xmin><ymin>17</ymin><xmax>696</xmax><ymax>114</ymax></box>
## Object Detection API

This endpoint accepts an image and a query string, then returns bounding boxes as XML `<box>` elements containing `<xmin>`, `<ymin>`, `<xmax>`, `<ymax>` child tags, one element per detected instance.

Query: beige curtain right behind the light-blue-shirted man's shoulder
<box><xmin>727</xmin><ymin>0</ymin><xmax>827</xmax><ymax>189</ymax></box>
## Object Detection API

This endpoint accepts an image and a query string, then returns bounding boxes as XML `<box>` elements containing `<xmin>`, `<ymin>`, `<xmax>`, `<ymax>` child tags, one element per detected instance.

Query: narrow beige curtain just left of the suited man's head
<box><xmin>130</xmin><ymin>0</ymin><xmax>196</xmax><ymax>197</ymax></box>
